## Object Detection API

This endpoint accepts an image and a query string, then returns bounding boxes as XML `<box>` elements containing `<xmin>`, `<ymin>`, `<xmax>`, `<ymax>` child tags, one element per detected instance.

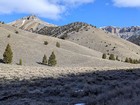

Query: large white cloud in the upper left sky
<box><xmin>0</xmin><ymin>0</ymin><xmax>94</xmax><ymax>19</ymax></box>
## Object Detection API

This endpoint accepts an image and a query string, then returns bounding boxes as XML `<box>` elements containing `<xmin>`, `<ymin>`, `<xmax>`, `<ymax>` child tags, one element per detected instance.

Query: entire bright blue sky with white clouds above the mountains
<box><xmin>0</xmin><ymin>0</ymin><xmax>140</xmax><ymax>27</ymax></box>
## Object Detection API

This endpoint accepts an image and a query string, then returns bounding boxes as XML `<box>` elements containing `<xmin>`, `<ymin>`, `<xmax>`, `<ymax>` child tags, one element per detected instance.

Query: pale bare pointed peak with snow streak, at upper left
<box><xmin>9</xmin><ymin>15</ymin><xmax>56</xmax><ymax>32</ymax></box>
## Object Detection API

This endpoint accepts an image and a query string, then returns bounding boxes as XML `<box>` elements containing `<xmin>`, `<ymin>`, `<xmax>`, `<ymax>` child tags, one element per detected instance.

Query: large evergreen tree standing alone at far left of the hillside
<box><xmin>3</xmin><ymin>44</ymin><xmax>13</xmax><ymax>64</ymax></box>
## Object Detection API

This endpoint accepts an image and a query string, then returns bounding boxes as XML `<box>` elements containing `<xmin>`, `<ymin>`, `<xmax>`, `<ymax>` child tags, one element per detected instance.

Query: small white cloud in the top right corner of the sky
<box><xmin>113</xmin><ymin>0</ymin><xmax>140</xmax><ymax>7</ymax></box>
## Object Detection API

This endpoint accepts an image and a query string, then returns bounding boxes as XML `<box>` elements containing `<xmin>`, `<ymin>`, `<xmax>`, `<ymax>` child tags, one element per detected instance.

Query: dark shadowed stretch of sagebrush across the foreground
<box><xmin>0</xmin><ymin>67</ymin><xmax>140</xmax><ymax>105</ymax></box>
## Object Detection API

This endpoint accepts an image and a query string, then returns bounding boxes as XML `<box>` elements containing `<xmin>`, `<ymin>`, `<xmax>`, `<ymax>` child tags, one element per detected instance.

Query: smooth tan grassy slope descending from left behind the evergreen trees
<box><xmin>0</xmin><ymin>24</ymin><xmax>131</xmax><ymax>66</ymax></box>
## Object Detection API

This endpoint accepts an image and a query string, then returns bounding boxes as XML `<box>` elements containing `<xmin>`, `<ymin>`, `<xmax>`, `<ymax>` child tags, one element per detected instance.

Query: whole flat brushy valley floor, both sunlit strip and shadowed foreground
<box><xmin>0</xmin><ymin>64</ymin><xmax>140</xmax><ymax>105</ymax></box>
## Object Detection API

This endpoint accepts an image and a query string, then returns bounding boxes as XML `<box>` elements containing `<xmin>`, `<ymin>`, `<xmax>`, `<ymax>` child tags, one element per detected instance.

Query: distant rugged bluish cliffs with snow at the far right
<box><xmin>101</xmin><ymin>26</ymin><xmax>140</xmax><ymax>39</ymax></box>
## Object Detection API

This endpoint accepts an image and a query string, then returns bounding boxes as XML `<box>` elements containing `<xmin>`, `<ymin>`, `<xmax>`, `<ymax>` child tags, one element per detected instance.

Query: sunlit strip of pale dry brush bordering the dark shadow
<box><xmin>0</xmin><ymin>64</ymin><xmax>140</xmax><ymax>80</ymax></box>
